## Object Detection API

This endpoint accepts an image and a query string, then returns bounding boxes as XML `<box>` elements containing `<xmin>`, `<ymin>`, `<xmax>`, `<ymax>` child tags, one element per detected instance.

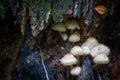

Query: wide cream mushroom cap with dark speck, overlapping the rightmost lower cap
<box><xmin>90</xmin><ymin>44</ymin><xmax>110</xmax><ymax>57</ymax></box>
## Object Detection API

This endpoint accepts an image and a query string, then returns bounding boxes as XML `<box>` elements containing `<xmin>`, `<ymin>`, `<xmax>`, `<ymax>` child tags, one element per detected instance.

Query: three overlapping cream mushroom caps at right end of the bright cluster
<box><xmin>81</xmin><ymin>37</ymin><xmax>110</xmax><ymax>64</ymax></box>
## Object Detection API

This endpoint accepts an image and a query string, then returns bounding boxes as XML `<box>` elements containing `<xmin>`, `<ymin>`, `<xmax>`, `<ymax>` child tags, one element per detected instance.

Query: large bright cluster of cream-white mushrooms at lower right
<box><xmin>60</xmin><ymin>37</ymin><xmax>110</xmax><ymax>76</ymax></box>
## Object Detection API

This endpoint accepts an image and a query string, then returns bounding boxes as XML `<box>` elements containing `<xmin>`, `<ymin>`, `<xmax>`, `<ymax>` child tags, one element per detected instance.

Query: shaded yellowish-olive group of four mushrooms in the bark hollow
<box><xmin>51</xmin><ymin>19</ymin><xmax>80</xmax><ymax>43</ymax></box>
